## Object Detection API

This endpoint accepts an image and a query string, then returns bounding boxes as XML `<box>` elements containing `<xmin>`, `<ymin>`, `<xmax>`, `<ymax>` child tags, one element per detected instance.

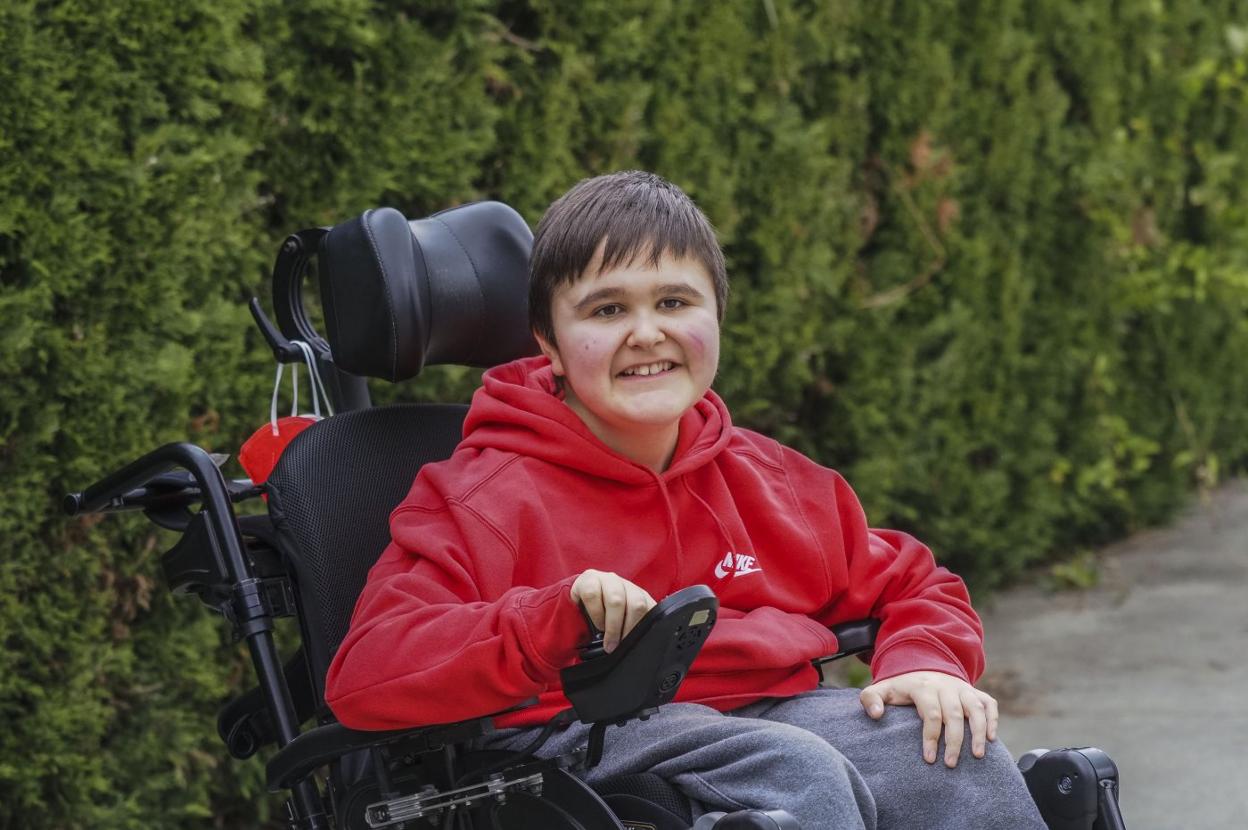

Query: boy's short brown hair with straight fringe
<box><xmin>529</xmin><ymin>170</ymin><xmax>728</xmax><ymax>343</ymax></box>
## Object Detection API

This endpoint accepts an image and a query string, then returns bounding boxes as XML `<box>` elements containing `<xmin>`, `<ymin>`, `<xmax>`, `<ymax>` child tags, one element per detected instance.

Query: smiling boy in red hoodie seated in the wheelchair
<box><xmin>326</xmin><ymin>171</ymin><xmax>1043</xmax><ymax>830</ymax></box>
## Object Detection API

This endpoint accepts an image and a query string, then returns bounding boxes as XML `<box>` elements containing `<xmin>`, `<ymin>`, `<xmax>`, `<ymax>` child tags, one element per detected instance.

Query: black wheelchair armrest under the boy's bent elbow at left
<box><xmin>265</xmin><ymin>698</ymin><xmax>537</xmax><ymax>793</ymax></box>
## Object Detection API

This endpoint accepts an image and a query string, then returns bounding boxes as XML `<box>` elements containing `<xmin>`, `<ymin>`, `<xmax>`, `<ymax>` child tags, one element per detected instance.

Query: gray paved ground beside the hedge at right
<box><xmin>981</xmin><ymin>482</ymin><xmax>1248</xmax><ymax>830</ymax></box>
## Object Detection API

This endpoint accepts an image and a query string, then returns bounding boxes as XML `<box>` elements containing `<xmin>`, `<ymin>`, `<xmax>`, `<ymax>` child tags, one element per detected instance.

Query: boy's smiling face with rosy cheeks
<box><xmin>538</xmin><ymin>248</ymin><xmax>719</xmax><ymax>449</ymax></box>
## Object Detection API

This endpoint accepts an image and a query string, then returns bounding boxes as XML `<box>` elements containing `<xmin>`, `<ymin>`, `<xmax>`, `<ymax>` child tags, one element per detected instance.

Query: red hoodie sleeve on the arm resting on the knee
<box><xmin>785</xmin><ymin>451</ymin><xmax>983</xmax><ymax>683</ymax></box>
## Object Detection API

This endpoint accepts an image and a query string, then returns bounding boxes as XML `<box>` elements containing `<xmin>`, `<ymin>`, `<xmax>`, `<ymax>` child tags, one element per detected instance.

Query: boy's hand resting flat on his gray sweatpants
<box><xmin>859</xmin><ymin>671</ymin><xmax>998</xmax><ymax>769</ymax></box>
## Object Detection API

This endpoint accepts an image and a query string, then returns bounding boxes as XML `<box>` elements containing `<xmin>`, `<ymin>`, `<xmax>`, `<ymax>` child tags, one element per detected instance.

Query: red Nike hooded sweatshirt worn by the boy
<box><xmin>326</xmin><ymin>357</ymin><xmax>983</xmax><ymax>729</ymax></box>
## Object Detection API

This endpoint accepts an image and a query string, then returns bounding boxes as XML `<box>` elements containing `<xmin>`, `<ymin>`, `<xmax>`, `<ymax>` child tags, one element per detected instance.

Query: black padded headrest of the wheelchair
<box><xmin>319</xmin><ymin>202</ymin><xmax>538</xmax><ymax>381</ymax></box>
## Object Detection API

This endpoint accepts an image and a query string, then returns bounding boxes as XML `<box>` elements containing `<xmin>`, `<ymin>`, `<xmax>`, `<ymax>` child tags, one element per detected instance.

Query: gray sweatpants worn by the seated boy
<box><xmin>488</xmin><ymin>689</ymin><xmax>1045</xmax><ymax>830</ymax></box>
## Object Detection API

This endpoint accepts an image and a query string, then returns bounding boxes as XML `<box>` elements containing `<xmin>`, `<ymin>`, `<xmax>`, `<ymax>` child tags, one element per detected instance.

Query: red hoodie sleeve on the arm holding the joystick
<box><xmin>326</xmin><ymin>482</ymin><xmax>584</xmax><ymax>729</ymax></box>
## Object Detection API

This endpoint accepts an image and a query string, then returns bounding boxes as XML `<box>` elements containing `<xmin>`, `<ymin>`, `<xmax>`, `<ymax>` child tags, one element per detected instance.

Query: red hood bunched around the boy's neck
<box><xmin>459</xmin><ymin>356</ymin><xmax>733</xmax><ymax>484</ymax></box>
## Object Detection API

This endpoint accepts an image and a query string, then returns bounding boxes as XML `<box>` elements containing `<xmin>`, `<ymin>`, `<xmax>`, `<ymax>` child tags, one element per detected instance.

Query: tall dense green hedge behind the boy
<box><xmin>0</xmin><ymin>0</ymin><xmax>1248</xmax><ymax>828</ymax></box>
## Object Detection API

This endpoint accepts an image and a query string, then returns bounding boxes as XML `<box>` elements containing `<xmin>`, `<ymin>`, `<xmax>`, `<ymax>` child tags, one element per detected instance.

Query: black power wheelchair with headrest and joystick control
<box><xmin>65</xmin><ymin>202</ymin><xmax>1123</xmax><ymax>830</ymax></box>
